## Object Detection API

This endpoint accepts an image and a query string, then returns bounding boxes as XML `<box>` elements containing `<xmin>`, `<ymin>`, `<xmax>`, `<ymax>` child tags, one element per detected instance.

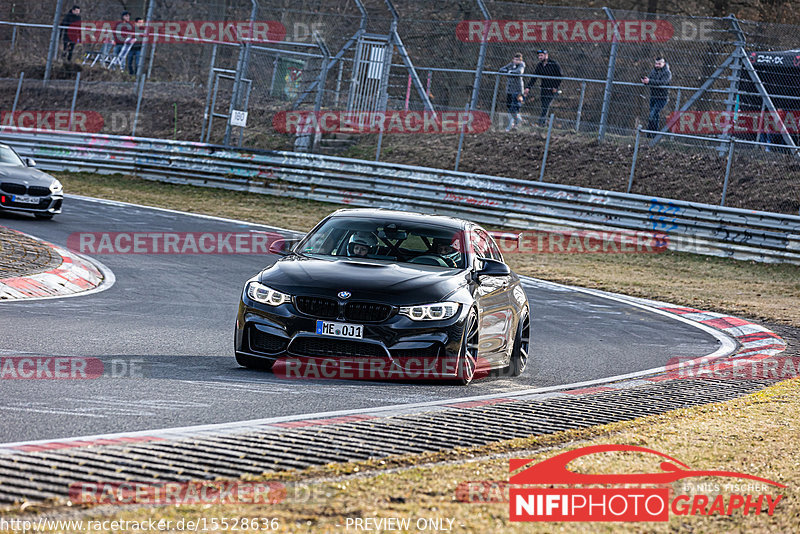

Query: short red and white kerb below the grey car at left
<box><xmin>0</xmin><ymin>234</ymin><xmax>109</xmax><ymax>301</ymax></box>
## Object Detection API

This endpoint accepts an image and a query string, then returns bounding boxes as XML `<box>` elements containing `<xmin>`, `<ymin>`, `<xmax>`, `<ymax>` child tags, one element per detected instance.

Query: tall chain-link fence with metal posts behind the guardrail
<box><xmin>0</xmin><ymin>0</ymin><xmax>800</xmax><ymax>213</ymax></box>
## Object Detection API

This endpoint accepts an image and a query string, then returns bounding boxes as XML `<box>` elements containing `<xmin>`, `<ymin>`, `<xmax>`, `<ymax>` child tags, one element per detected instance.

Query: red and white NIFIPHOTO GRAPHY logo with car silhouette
<box><xmin>508</xmin><ymin>445</ymin><xmax>786</xmax><ymax>522</ymax></box>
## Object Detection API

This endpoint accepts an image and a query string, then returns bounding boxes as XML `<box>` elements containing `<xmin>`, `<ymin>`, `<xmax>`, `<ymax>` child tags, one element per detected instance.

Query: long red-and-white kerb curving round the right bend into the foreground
<box><xmin>0</xmin><ymin>279</ymin><xmax>786</xmax><ymax>455</ymax></box>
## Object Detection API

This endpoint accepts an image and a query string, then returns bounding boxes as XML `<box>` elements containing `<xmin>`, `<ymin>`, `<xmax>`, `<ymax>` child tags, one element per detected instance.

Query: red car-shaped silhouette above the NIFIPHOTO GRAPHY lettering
<box><xmin>508</xmin><ymin>445</ymin><xmax>786</xmax><ymax>488</ymax></box>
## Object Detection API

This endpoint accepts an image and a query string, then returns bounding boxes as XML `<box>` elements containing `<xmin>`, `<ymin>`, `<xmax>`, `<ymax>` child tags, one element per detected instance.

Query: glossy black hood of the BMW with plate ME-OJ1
<box><xmin>259</xmin><ymin>256</ymin><xmax>466</xmax><ymax>306</ymax></box>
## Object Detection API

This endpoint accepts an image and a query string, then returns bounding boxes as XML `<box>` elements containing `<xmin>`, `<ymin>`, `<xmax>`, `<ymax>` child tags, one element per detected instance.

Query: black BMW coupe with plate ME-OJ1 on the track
<box><xmin>235</xmin><ymin>209</ymin><xmax>531</xmax><ymax>384</ymax></box>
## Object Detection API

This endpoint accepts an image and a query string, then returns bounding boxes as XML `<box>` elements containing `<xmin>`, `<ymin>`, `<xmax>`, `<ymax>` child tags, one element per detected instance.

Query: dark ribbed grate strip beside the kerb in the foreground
<box><xmin>0</xmin><ymin>380</ymin><xmax>774</xmax><ymax>503</ymax></box>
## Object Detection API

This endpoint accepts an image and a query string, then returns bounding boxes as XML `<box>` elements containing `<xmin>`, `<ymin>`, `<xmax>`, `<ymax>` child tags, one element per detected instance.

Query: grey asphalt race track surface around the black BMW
<box><xmin>0</xmin><ymin>198</ymin><xmax>720</xmax><ymax>443</ymax></box>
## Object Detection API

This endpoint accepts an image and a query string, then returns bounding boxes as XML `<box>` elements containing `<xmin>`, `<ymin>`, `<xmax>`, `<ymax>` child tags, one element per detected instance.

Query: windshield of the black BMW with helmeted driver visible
<box><xmin>296</xmin><ymin>217</ymin><xmax>465</xmax><ymax>269</ymax></box>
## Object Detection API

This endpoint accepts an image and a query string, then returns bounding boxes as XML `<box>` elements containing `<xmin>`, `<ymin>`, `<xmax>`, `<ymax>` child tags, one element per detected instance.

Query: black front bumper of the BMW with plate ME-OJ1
<box><xmin>235</xmin><ymin>296</ymin><xmax>467</xmax><ymax>379</ymax></box>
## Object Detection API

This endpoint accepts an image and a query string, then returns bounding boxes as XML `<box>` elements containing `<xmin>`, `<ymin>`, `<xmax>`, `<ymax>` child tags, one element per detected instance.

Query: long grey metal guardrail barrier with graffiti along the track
<box><xmin>0</xmin><ymin>128</ymin><xmax>800</xmax><ymax>264</ymax></box>
